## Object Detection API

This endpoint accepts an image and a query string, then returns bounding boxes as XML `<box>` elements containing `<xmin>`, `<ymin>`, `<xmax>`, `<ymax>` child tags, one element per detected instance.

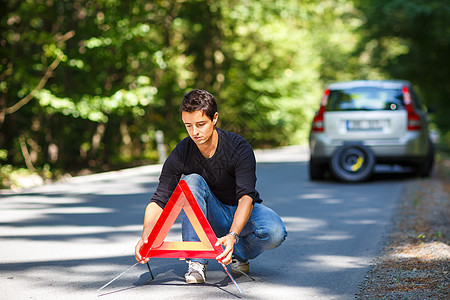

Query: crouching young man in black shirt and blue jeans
<box><xmin>135</xmin><ymin>89</ymin><xmax>287</xmax><ymax>283</ymax></box>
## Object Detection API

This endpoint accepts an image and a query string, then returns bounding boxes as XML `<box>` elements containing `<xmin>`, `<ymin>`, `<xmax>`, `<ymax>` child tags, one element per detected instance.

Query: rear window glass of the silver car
<box><xmin>326</xmin><ymin>87</ymin><xmax>404</xmax><ymax>111</ymax></box>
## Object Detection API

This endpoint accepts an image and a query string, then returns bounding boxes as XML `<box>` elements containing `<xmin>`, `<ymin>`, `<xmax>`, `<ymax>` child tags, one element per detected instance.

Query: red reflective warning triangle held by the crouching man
<box><xmin>140</xmin><ymin>180</ymin><xmax>223</xmax><ymax>258</ymax></box>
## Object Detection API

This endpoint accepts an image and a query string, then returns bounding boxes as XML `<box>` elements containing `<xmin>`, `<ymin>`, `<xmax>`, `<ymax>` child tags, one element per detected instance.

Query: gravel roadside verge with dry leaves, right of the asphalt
<box><xmin>356</xmin><ymin>152</ymin><xmax>450</xmax><ymax>299</ymax></box>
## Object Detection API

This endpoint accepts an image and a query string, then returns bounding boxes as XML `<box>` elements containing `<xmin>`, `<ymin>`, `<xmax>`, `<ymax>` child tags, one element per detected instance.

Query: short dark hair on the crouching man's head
<box><xmin>180</xmin><ymin>89</ymin><xmax>217</xmax><ymax>120</ymax></box>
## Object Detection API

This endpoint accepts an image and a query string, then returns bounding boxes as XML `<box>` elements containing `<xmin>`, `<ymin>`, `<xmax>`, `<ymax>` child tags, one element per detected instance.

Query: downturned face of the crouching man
<box><xmin>181</xmin><ymin>111</ymin><xmax>219</xmax><ymax>146</ymax></box>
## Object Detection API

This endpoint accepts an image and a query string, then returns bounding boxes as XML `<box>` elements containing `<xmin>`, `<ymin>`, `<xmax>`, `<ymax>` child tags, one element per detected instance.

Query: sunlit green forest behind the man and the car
<box><xmin>0</xmin><ymin>0</ymin><xmax>450</xmax><ymax>188</ymax></box>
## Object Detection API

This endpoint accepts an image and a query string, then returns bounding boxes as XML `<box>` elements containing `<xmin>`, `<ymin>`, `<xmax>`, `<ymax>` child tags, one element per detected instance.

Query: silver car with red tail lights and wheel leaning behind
<box><xmin>309</xmin><ymin>80</ymin><xmax>434</xmax><ymax>182</ymax></box>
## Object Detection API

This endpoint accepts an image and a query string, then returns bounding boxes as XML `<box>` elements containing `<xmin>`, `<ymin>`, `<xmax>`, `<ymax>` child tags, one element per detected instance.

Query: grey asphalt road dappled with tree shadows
<box><xmin>0</xmin><ymin>147</ymin><xmax>414</xmax><ymax>299</ymax></box>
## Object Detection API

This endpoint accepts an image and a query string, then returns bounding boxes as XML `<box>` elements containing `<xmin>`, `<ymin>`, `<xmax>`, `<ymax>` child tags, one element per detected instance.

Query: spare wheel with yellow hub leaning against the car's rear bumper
<box><xmin>330</xmin><ymin>144</ymin><xmax>375</xmax><ymax>182</ymax></box>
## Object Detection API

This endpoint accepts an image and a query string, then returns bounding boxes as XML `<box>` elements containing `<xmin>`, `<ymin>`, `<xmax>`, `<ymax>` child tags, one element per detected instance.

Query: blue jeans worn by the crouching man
<box><xmin>181</xmin><ymin>174</ymin><xmax>287</xmax><ymax>264</ymax></box>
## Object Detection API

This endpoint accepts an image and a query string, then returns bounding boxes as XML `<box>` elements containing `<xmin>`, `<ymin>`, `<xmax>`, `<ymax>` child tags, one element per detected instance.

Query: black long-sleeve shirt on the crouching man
<box><xmin>150</xmin><ymin>128</ymin><xmax>262</xmax><ymax>208</ymax></box>
